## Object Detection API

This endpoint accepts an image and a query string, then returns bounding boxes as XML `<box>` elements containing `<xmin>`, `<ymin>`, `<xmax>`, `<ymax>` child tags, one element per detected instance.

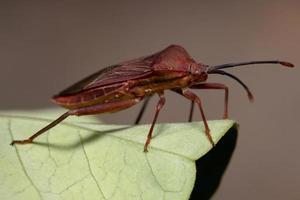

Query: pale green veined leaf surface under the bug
<box><xmin>0</xmin><ymin>111</ymin><xmax>235</xmax><ymax>200</ymax></box>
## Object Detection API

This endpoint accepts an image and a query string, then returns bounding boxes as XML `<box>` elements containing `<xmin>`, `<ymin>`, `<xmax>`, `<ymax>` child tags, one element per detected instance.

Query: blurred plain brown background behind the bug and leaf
<box><xmin>0</xmin><ymin>0</ymin><xmax>300</xmax><ymax>199</ymax></box>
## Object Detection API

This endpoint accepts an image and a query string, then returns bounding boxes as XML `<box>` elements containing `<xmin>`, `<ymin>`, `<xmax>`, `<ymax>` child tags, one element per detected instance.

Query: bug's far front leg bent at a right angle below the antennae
<box><xmin>190</xmin><ymin>83</ymin><xmax>229</xmax><ymax>119</ymax></box>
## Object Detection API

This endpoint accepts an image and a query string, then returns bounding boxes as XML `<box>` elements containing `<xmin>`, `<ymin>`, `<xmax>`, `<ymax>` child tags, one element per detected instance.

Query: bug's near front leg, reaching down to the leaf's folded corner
<box><xmin>173</xmin><ymin>89</ymin><xmax>215</xmax><ymax>146</ymax></box>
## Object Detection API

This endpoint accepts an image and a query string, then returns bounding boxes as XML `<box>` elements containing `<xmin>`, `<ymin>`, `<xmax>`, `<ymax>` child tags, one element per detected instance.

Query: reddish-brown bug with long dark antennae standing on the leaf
<box><xmin>11</xmin><ymin>45</ymin><xmax>293</xmax><ymax>151</ymax></box>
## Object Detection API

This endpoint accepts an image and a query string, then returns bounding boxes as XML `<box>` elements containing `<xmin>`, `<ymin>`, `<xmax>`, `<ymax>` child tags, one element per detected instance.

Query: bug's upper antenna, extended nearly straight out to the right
<box><xmin>207</xmin><ymin>60</ymin><xmax>294</xmax><ymax>72</ymax></box>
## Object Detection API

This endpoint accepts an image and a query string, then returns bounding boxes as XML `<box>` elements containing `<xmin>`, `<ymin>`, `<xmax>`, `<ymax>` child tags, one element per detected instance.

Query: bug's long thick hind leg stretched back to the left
<box><xmin>10</xmin><ymin>98</ymin><xmax>142</xmax><ymax>145</ymax></box>
